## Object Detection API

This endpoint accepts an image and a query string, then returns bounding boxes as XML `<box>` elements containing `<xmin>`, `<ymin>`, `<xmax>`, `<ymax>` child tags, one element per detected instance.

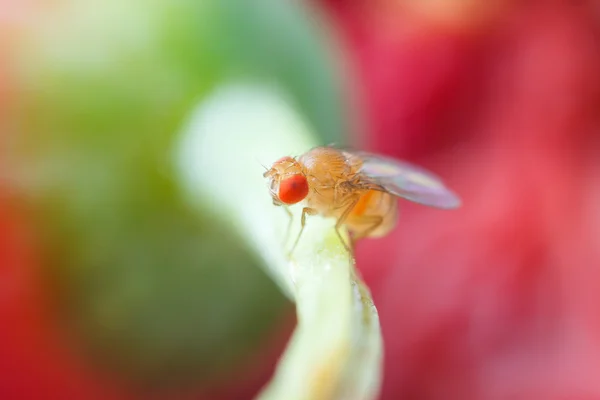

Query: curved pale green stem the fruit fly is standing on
<box><xmin>176</xmin><ymin>83</ymin><xmax>382</xmax><ymax>400</ymax></box>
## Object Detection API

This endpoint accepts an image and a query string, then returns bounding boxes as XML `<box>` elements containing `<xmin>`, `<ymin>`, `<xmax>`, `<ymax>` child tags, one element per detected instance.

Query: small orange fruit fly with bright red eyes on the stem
<box><xmin>264</xmin><ymin>146</ymin><xmax>461</xmax><ymax>255</ymax></box>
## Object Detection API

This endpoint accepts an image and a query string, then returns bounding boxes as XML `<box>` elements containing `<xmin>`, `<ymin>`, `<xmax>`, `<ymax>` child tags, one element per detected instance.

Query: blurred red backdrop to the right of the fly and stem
<box><xmin>324</xmin><ymin>0</ymin><xmax>600</xmax><ymax>400</ymax></box>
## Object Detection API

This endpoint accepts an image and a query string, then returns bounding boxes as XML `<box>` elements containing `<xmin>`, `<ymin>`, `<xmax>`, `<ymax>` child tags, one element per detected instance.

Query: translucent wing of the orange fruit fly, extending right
<box><xmin>347</xmin><ymin>152</ymin><xmax>461</xmax><ymax>208</ymax></box>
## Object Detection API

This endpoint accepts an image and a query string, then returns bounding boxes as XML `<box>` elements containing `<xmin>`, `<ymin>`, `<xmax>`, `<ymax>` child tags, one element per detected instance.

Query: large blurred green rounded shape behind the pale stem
<box><xmin>11</xmin><ymin>0</ymin><xmax>346</xmax><ymax>392</ymax></box>
